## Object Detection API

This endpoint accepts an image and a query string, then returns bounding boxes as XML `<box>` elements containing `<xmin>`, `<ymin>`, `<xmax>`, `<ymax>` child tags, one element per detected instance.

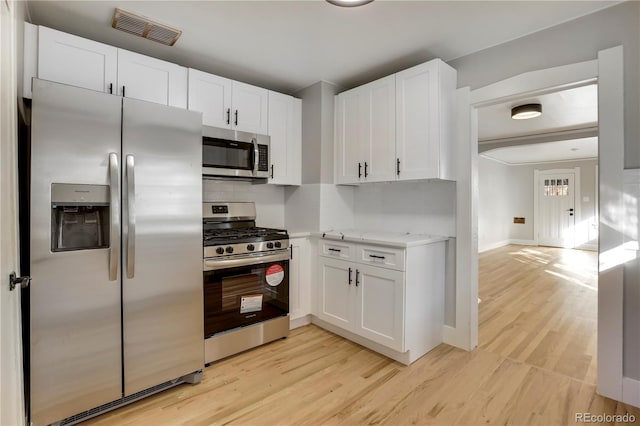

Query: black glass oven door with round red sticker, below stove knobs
<box><xmin>204</xmin><ymin>256</ymin><xmax>289</xmax><ymax>338</ymax></box>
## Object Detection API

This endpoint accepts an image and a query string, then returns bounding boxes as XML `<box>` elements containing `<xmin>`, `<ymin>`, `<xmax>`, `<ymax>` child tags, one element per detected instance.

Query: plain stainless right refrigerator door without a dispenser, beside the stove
<box><xmin>122</xmin><ymin>98</ymin><xmax>204</xmax><ymax>396</ymax></box>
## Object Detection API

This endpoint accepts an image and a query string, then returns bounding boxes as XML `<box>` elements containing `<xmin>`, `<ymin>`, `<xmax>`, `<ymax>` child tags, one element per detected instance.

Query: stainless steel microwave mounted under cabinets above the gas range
<box><xmin>202</xmin><ymin>126</ymin><xmax>270</xmax><ymax>179</ymax></box>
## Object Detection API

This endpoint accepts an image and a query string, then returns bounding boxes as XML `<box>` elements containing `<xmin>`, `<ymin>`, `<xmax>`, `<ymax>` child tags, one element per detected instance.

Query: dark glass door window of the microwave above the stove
<box><xmin>202</xmin><ymin>136</ymin><xmax>255</xmax><ymax>170</ymax></box>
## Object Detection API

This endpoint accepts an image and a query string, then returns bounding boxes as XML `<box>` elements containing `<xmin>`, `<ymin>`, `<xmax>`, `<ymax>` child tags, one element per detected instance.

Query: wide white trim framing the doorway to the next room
<box><xmin>456</xmin><ymin>46</ymin><xmax>624</xmax><ymax>402</ymax></box>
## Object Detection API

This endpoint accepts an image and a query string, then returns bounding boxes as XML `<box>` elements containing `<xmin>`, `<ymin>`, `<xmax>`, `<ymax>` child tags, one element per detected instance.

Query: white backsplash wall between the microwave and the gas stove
<box><xmin>202</xmin><ymin>179</ymin><xmax>285</xmax><ymax>228</ymax></box>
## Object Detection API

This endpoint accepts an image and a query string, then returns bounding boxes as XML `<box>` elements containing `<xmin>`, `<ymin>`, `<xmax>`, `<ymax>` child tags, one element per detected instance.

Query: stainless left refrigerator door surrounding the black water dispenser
<box><xmin>30</xmin><ymin>80</ymin><xmax>122</xmax><ymax>425</ymax></box>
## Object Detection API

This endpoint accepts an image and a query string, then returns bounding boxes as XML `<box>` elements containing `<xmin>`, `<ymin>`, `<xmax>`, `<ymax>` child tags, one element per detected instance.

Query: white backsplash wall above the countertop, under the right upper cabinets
<box><xmin>354</xmin><ymin>181</ymin><xmax>456</xmax><ymax>236</ymax></box>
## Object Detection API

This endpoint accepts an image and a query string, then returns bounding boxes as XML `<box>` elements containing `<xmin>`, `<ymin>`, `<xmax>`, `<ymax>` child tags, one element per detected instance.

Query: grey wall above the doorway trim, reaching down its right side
<box><xmin>449</xmin><ymin>1</ymin><xmax>640</xmax><ymax>168</ymax></box>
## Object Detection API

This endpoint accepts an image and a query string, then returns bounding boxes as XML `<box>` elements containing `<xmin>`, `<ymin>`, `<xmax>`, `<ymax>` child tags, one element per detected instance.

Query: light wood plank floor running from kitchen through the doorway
<box><xmin>87</xmin><ymin>246</ymin><xmax>640</xmax><ymax>426</ymax></box>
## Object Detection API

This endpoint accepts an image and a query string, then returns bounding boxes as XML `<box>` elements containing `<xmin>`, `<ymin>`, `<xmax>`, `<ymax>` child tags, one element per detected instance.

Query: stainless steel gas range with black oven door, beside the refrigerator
<box><xmin>202</xmin><ymin>202</ymin><xmax>290</xmax><ymax>363</ymax></box>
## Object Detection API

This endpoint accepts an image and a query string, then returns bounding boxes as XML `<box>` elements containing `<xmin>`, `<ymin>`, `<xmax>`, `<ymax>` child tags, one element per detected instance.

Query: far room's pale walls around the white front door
<box><xmin>478</xmin><ymin>156</ymin><xmax>598</xmax><ymax>252</ymax></box>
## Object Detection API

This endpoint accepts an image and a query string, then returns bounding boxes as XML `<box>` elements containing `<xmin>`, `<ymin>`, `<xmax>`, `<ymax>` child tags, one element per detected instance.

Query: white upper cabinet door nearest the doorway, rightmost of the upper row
<box><xmin>396</xmin><ymin>61</ymin><xmax>439</xmax><ymax>180</ymax></box>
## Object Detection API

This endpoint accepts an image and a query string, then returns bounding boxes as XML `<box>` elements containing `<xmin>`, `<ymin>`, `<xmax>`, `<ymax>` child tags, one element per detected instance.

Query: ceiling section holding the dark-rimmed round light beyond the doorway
<box><xmin>478</xmin><ymin>84</ymin><xmax>598</xmax><ymax>141</ymax></box>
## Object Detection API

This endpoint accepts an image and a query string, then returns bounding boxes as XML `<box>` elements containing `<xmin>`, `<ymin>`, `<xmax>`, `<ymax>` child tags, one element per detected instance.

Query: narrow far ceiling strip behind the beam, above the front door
<box><xmin>481</xmin><ymin>137</ymin><xmax>598</xmax><ymax>165</ymax></box>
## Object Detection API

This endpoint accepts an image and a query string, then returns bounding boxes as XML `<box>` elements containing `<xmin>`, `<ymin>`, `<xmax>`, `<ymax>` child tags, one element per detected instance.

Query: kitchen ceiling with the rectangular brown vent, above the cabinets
<box><xmin>28</xmin><ymin>0</ymin><xmax>620</xmax><ymax>93</ymax></box>
